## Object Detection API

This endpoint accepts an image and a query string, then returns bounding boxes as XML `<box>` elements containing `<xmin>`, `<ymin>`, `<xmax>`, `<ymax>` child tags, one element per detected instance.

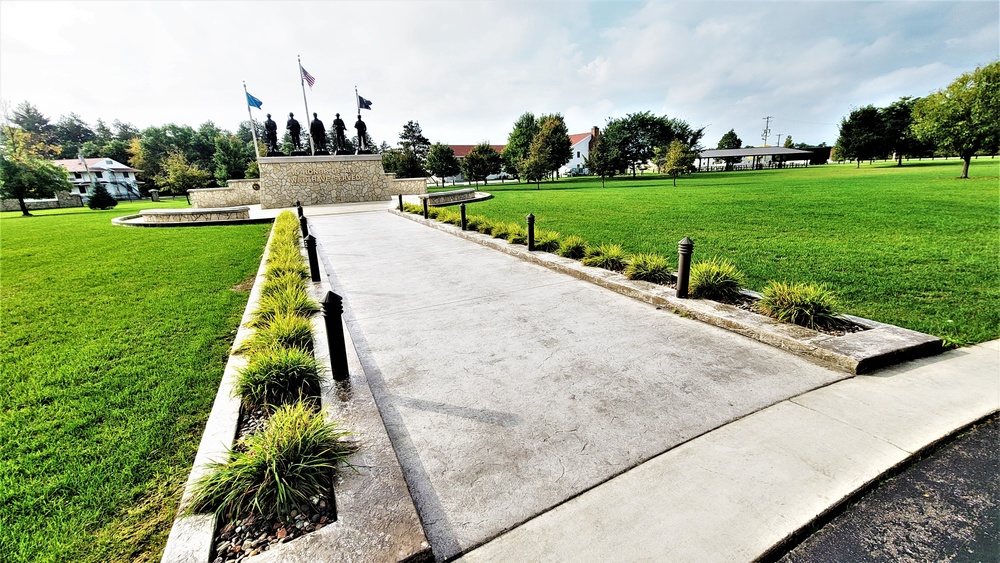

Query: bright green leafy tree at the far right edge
<box><xmin>913</xmin><ymin>61</ymin><xmax>1000</xmax><ymax>178</ymax></box>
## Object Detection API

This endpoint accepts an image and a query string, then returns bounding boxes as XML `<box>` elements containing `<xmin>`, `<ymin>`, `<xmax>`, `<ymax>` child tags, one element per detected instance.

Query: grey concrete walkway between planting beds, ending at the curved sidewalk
<box><xmin>306</xmin><ymin>207</ymin><xmax>860</xmax><ymax>560</ymax></box>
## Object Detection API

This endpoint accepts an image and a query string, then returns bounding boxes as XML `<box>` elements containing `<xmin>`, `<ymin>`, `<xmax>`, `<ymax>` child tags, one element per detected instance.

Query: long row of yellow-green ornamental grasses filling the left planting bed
<box><xmin>185</xmin><ymin>211</ymin><xmax>356</xmax><ymax>563</ymax></box>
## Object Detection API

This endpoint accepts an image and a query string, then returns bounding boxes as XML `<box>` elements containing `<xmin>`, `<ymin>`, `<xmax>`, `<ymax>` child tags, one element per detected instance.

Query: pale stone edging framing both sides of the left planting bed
<box><xmin>162</xmin><ymin>216</ymin><xmax>431</xmax><ymax>563</ymax></box>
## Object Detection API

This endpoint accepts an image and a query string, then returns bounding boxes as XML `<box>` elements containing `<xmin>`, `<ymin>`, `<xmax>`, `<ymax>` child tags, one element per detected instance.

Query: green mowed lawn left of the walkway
<box><xmin>0</xmin><ymin>199</ymin><xmax>269</xmax><ymax>562</ymax></box>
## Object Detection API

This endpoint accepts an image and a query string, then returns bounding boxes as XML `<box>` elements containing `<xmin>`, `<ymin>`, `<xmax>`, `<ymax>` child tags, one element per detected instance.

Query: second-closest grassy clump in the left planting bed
<box><xmin>233</xmin><ymin>347</ymin><xmax>322</xmax><ymax>409</ymax></box>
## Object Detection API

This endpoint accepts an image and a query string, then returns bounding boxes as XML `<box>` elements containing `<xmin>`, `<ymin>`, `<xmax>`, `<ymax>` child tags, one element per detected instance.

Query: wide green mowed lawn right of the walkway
<box><xmin>466</xmin><ymin>158</ymin><xmax>1000</xmax><ymax>345</ymax></box>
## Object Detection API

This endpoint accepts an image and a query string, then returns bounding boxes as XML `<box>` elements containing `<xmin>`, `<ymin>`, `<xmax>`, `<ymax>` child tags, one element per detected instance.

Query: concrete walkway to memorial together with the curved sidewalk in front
<box><xmin>306</xmin><ymin>204</ymin><xmax>1000</xmax><ymax>561</ymax></box>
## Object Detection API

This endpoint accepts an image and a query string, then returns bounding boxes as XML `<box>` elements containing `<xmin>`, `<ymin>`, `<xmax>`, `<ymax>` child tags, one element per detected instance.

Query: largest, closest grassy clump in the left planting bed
<box><xmin>187</xmin><ymin>402</ymin><xmax>357</xmax><ymax>519</ymax></box>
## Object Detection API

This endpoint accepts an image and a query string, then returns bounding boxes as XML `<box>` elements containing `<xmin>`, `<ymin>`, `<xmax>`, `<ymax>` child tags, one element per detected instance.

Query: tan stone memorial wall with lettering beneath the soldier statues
<box><xmin>257</xmin><ymin>154</ymin><xmax>427</xmax><ymax>209</ymax></box>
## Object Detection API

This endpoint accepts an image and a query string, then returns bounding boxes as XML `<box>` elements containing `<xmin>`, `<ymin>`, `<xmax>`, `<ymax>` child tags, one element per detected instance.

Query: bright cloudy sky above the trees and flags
<box><xmin>0</xmin><ymin>0</ymin><xmax>1000</xmax><ymax>147</ymax></box>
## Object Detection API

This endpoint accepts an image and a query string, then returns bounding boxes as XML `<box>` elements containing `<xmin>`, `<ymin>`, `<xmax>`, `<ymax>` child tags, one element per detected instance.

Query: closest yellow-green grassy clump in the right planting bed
<box><xmin>754</xmin><ymin>281</ymin><xmax>844</xmax><ymax>330</ymax></box>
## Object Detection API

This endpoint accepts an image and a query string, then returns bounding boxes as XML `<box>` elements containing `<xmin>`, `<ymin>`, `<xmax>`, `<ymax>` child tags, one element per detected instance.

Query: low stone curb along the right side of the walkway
<box><xmin>389</xmin><ymin>208</ymin><xmax>942</xmax><ymax>375</ymax></box>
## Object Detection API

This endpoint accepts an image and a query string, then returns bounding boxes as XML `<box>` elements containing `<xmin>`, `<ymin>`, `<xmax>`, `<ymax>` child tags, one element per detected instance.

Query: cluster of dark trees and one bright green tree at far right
<box><xmin>834</xmin><ymin>61</ymin><xmax>1000</xmax><ymax>178</ymax></box>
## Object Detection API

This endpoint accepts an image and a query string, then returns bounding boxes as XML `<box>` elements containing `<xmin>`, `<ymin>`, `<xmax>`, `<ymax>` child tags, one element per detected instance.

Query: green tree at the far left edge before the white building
<box><xmin>0</xmin><ymin>126</ymin><xmax>73</xmax><ymax>216</ymax></box>
